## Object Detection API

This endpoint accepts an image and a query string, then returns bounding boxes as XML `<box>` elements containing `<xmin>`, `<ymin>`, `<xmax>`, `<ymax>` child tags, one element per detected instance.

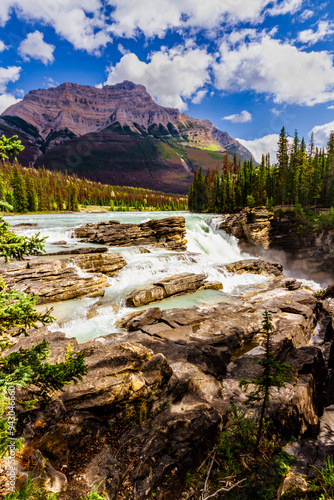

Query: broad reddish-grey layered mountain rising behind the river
<box><xmin>0</xmin><ymin>81</ymin><xmax>252</xmax><ymax>193</ymax></box>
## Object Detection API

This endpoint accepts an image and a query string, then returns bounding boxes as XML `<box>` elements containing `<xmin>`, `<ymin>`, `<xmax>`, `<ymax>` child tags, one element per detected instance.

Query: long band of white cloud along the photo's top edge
<box><xmin>0</xmin><ymin>0</ymin><xmax>303</xmax><ymax>53</ymax></box>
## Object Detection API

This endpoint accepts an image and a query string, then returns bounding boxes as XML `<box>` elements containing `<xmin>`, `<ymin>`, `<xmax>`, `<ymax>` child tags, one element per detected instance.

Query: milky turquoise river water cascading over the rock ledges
<box><xmin>3</xmin><ymin>212</ymin><xmax>267</xmax><ymax>342</ymax></box>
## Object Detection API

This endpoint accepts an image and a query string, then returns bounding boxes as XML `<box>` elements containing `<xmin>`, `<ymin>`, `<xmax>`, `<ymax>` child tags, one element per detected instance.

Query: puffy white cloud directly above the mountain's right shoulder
<box><xmin>106</xmin><ymin>46</ymin><xmax>213</xmax><ymax>110</ymax></box>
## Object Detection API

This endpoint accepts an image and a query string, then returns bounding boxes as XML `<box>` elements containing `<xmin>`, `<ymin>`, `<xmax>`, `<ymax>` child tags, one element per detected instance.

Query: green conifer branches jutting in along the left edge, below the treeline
<box><xmin>0</xmin><ymin>221</ymin><xmax>87</xmax><ymax>460</ymax></box>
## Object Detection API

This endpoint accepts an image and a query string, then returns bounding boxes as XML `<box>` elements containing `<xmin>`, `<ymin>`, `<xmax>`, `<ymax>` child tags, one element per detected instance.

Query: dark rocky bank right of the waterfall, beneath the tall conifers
<box><xmin>215</xmin><ymin>207</ymin><xmax>334</xmax><ymax>283</ymax></box>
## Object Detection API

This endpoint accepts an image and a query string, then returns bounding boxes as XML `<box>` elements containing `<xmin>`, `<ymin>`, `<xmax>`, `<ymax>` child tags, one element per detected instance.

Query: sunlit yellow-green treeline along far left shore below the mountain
<box><xmin>0</xmin><ymin>162</ymin><xmax>188</xmax><ymax>213</ymax></box>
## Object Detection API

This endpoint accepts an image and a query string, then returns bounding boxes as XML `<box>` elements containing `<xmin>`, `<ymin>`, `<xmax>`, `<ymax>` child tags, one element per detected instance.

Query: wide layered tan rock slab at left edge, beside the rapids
<box><xmin>0</xmin><ymin>254</ymin><xmax>126</xmax><ymax>304</ymax></box>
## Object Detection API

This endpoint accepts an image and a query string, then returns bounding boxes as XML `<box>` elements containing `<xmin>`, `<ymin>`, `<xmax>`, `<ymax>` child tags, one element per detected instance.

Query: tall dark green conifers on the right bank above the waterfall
<box><xmin>188</xmin><ymin>127</ymin><xmax>334</xmax><ymax>213</ymax></box>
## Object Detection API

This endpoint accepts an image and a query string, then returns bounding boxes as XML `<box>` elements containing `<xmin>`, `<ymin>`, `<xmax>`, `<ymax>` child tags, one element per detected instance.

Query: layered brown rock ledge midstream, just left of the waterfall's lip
<box><xmin>75</xmin><ymin>217</ymin><xmax>187</xmax><ymax>251</ymax></box>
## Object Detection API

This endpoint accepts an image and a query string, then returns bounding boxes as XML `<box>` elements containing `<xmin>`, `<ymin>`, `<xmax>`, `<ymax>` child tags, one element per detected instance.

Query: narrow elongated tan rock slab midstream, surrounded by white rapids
<box><xmin>125</xmin><ymin>273</ymin><xmax>223</xmax><ymax>307</ymax></box>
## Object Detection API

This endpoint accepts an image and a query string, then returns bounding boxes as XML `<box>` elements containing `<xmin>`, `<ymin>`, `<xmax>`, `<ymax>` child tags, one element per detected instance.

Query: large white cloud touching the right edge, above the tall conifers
<box><xmin>214</xmin><ymin>33</ymin><xmax>334</xmax><ymax>106</ymax></box>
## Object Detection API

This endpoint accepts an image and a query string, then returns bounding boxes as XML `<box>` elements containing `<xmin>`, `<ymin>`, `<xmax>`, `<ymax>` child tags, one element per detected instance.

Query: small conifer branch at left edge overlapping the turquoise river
<box><xmin>0</xmin><ymin>217</ymin><xmax>46</xmax><ymax>262</ymax></box>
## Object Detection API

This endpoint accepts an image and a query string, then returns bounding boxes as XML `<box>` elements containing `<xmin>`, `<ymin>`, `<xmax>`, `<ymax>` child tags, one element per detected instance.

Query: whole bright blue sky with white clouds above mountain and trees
<box><xmin>0</xmin><ymin>0</ymin><xmax>334</xmax><ymax>160</ymax></box>
